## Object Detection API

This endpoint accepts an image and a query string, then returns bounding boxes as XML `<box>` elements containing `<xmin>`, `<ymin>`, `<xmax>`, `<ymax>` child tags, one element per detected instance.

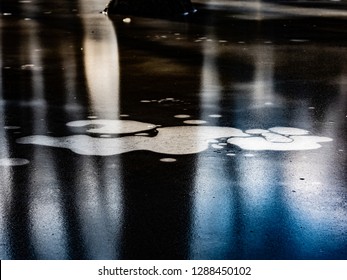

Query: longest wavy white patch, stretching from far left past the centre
<box><xmin>17</xmin><ymin>126</ymin><xmax>248</xmax><ymax>156</ymax></box>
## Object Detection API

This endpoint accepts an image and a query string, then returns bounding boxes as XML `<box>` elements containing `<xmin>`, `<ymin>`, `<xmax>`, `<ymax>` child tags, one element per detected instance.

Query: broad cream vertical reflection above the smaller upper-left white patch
<box><xmin>81</xmin><ymin>2</ymin><xmax>119</xmax><ymax>119</ymax></box>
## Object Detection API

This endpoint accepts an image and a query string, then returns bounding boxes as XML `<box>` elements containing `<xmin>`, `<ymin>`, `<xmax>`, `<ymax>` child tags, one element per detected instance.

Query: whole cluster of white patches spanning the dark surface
<box><xmin>17</xmin><ymin>120</ymin><xmax>332</xmax><ymax>156</ymax></box>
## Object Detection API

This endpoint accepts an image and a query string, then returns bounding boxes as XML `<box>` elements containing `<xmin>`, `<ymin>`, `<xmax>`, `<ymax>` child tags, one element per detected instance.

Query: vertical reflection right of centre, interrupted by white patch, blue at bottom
<box><xmin>189</xmin><ymin>30</ymin><xmax>234</xmax><ymax>259</ymax></box>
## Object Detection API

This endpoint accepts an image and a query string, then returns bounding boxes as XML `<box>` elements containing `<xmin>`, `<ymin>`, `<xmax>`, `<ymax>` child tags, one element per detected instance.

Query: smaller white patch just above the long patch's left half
<box><xmin>67</xmin><ymin>120</ymin><xmax>156</xmax><ymax>134</ymax></box>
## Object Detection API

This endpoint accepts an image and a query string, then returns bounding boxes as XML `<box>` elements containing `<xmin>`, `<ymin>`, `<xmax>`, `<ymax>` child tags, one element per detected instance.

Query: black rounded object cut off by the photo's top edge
<box><xmin>104</xmin><ymin>0</ymin><xmax>196</xmax><ymax>18</ymax></box>
